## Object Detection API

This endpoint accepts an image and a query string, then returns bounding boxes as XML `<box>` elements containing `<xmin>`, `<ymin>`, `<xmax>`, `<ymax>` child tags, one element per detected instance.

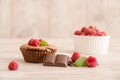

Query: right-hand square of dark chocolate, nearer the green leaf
<box><xmin>55</xmin><ymin>54</ymin><xmax>69</xmax><ymax>67</ymax></box>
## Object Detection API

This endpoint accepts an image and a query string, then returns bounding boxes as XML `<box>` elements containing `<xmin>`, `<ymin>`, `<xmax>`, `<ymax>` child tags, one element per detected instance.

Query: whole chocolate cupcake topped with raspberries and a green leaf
<box><xmin>20</xmin><ymin>39</ymin><xmax>57</xmax><ymax>63</ymax></box>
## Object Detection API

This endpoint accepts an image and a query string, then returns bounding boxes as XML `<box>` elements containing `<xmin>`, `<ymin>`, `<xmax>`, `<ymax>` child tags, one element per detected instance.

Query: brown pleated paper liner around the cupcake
<box><xmin>20</xmin><ymin>44</ymin><xmax>57</xmax><ymax>63</ymax></box>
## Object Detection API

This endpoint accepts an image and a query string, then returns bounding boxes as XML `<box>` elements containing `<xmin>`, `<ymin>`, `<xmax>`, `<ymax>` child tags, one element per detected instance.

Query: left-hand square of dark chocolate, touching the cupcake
<box><xmin>43</xmin><ymin>54</ymin><xmax>55</xmax><ymax>66</ymax></box>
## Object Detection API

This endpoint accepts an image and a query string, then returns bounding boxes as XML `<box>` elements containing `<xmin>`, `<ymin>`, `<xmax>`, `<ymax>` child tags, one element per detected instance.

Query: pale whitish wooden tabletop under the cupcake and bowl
<box><xmin>0</xmin><ymin>38</ymin><xmax>120</xmax><ymax>80</ymax></box>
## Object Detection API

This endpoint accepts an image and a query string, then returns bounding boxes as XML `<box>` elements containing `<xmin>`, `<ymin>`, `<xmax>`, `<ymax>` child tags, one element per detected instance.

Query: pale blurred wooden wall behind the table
<box><xmin>0</xmin><ymin>0</ymin><xmax>120</xmax><ymax>38</ymax></box>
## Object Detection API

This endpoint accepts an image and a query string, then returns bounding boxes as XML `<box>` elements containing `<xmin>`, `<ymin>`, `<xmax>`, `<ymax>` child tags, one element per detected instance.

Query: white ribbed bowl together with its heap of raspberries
<box><xmin>74</xmin><ymin>26</ymin><xmax>110</xmax><ymax>55</ymax></box>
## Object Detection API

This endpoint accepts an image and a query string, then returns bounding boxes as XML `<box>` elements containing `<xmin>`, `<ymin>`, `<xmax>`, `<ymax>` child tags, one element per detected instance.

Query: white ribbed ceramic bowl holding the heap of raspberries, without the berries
<box><xmin>74</xmin><ymin>35</ymin><xmax>110</xmax><ymax>55</ymax></box>
